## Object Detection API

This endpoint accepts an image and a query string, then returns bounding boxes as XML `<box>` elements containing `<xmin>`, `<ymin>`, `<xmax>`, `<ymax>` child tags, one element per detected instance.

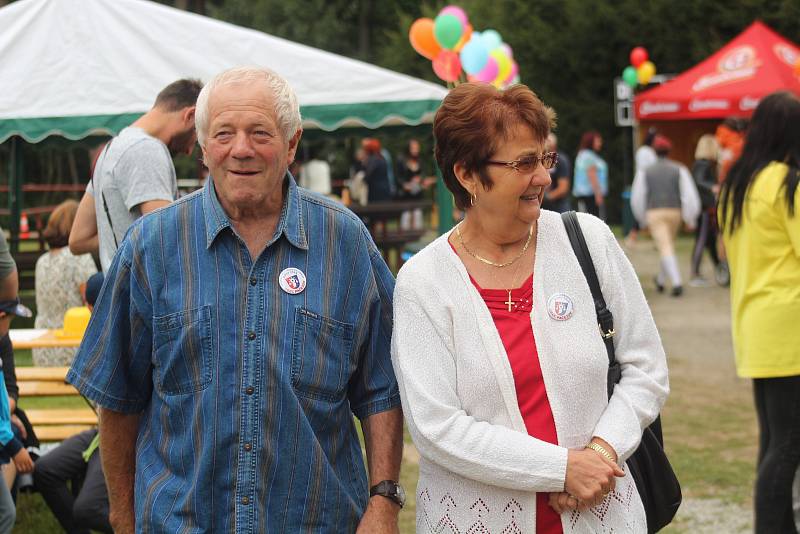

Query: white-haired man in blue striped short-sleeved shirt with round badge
<box><xmin>68</xmin><ymin>68</ymin><xmax>403</xmax><ymax>534</ymax></box>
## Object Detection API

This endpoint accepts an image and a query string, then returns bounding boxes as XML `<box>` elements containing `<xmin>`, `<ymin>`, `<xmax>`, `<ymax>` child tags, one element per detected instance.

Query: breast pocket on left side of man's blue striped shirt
<box><xmin>153</xmin><ymin>306</ymin><xmax>212</xmax><ymax>395</ymax></box>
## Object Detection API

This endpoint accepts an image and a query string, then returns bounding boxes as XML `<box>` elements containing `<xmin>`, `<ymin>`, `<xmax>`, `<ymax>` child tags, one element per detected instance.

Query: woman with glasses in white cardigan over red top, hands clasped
<box><xmin>392</xmin><ymin>83</ymin><xmax>668</xmax><ymax>534</ymax></box>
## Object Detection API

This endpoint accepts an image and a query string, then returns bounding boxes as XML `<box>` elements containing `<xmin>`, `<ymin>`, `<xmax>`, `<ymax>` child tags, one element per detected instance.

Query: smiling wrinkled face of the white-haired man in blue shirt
<box><xmin>203</xmin><ymin>83</ymin><xmax>302</xmax><ymax>214</ymax></box>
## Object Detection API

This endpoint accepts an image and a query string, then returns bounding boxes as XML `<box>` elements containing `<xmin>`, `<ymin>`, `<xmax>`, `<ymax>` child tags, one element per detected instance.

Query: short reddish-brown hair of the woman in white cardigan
<box><xmin>433</xmin><ymin>83</ymin><xmax>555</xmax><ymax>210</ymax></box>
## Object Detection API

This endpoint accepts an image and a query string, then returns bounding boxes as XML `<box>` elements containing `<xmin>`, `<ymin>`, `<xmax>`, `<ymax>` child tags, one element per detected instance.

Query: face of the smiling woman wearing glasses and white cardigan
<box><xmin>472</xmin><ymin>125</ymin><xmax>551</xmax><ymax>231</ymax></box>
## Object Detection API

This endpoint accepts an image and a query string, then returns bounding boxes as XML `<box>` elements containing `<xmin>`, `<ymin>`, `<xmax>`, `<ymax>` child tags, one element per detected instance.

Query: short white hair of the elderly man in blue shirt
<box><xmin>194</xmin><ymin>67</ymin><xmax>301</xmax><ymax>147</ymax></box>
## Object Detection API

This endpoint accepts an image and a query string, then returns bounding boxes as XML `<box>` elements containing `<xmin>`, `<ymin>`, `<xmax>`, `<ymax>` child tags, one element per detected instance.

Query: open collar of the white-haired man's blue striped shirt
<box><xmin>203</xmin><ymin>172</ymin><xmax>308</xmax><ymax>250</ymax></box>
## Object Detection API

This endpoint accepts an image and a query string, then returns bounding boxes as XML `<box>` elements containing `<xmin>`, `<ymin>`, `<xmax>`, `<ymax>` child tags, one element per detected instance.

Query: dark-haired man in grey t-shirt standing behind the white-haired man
<box><xmin>69</xmin><ymin>80</ymin><xmax>203</xmax><ymax>272</ymax></box>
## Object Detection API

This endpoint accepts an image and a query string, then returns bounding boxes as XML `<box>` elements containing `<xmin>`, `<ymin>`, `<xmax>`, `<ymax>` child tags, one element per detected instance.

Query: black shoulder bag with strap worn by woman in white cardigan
<box><xmin>561</xmin><ymin>211</ymin><xmax>681</xmax><ymax>533</ymax></box>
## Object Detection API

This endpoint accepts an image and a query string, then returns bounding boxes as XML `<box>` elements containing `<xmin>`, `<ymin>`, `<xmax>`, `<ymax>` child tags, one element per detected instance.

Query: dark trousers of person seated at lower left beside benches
<box><xmin>33</xmin><ymin>430</ymin><xmax>113</xmax><ymax>534</ymax></box>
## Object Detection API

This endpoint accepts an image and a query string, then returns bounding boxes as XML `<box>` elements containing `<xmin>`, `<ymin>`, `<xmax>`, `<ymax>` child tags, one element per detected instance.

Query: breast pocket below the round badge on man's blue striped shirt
<box><xmin>292</xmin><ymin>308</ymin><xmax>353</xmax><ymax>402</ymax></box>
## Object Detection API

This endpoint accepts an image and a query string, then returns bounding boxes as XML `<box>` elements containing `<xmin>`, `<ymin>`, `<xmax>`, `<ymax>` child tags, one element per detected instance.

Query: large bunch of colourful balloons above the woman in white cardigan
<box><xmin>408</xmin><ymin>6</ymin><xmax>519</xmax><ymax>88</ymax></box>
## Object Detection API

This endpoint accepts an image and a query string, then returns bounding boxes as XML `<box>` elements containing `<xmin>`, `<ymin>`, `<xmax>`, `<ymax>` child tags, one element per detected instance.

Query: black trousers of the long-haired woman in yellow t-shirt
<box><xmin>753</xmin><ymin>376</ymin><xmax>800</xmax><ymax>534</ymax></box>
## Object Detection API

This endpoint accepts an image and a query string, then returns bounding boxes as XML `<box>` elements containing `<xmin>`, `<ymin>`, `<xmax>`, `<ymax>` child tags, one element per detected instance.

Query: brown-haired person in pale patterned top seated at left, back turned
<box><xmin>32</xmin><ymin>200</ymin><xmax>97</xmax><ymax>367</ymax></box>
